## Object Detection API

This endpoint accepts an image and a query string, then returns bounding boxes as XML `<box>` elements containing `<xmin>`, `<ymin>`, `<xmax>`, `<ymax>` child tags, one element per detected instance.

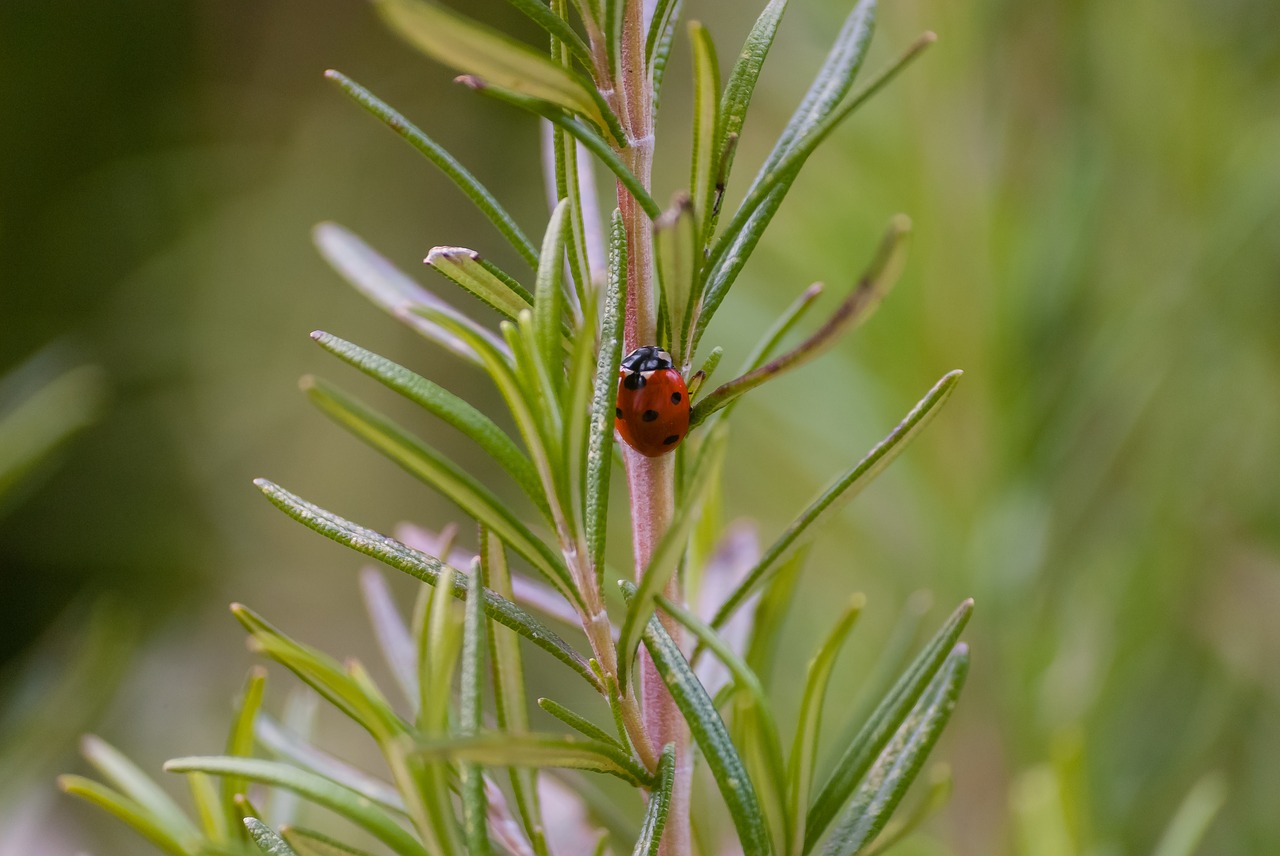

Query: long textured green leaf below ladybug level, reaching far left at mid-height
<box><xmin>253</xmin><ymin>479</ymin><xmax>603</xmax><ymax>691</ymax></box>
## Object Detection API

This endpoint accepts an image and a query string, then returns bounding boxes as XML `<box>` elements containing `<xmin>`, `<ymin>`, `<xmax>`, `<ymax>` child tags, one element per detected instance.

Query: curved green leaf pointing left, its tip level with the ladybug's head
<box><xmin>311</xmin><ymin>330</ymin><xmax>550</xmax><ymax>516</ymax></box>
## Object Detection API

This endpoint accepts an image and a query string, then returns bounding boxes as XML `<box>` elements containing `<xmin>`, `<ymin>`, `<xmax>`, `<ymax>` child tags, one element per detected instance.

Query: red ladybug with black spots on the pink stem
<box><xmin>613</xmin><ymin>344</ymin><xmax>689</xmax><ymax>458</ymax></box>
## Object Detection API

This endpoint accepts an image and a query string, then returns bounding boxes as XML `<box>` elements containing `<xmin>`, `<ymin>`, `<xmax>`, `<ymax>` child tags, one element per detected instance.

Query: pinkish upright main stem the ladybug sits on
<box><xmin>613</xmin><ymin>0</ymin><xmax>692</xmax><ymax>856</ymax></box>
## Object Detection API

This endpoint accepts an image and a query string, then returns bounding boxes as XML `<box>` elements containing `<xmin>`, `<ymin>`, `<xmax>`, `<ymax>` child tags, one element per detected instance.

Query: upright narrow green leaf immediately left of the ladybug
<box><xmin>584</xmin><ymin>209</ymin><xmax>627</xmax><ymax>591</ymax></box>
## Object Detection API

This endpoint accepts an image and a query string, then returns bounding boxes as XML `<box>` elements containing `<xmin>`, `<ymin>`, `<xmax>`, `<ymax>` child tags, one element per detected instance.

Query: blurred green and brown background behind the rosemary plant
<box><xmin>0</xmin><ymin>0</ymin><xmax>1280</xmax><ymax>856</ymax></box>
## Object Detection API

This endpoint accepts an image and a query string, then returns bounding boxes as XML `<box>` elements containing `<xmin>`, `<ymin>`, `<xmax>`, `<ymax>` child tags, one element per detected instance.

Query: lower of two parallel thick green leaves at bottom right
<box><xmin>823</xmin><ymin>644</ymin><xmax>969</xmax><ymax>856</ymax></box>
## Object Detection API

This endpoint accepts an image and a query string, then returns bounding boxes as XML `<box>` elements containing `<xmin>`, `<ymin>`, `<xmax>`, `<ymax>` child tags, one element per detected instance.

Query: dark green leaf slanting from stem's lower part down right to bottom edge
<box><xmin>620</xmin><ymin>580</ymin><xmax>773</xmax><ymax>856</ymax></box>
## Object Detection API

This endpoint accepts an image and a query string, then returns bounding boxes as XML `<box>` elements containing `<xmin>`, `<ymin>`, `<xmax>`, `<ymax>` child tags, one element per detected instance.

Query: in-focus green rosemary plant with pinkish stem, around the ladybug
<box><xmin>61</xmin><ymin>0</ymin><xmax>972</xmax><ymax>856</ymax></box>
